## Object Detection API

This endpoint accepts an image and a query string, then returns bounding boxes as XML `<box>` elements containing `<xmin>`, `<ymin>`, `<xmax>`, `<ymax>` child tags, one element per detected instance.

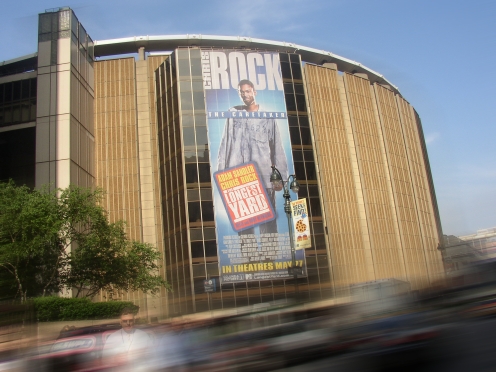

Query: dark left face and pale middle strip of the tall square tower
<box><xmin>35</xmin><ymin>11</ymin><xmax>71</xmax><ymax>187</ymax></box>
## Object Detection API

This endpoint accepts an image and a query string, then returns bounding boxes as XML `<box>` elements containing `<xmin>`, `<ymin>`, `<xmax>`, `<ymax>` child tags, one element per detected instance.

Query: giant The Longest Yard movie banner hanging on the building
<box><xmin>202</xmin><ymin>50</ymin><xmax>306</xmax><ymax>283</ymax></box>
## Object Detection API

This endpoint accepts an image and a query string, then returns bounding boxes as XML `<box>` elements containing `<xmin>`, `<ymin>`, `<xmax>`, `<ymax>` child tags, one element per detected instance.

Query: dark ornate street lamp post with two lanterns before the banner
<box><xmin>270</xmin><ymin>165</ymin><xmax>301</xmax><ymax>300</ymax></box>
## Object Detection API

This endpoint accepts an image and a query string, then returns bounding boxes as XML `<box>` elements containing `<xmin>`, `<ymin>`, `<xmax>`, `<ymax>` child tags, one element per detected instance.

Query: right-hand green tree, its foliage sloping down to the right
<box><xmin>60</xmin><ymin>187</ymin><xmax>169</xmax><ymax>297</ymax></box>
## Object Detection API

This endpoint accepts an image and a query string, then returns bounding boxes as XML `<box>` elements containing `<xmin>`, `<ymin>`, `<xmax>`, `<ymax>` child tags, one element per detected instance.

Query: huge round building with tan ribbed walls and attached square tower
<box><xmin>0</xmin><ymin>8</ymin><xmax>444</xmax><ymax>316</ymax></box>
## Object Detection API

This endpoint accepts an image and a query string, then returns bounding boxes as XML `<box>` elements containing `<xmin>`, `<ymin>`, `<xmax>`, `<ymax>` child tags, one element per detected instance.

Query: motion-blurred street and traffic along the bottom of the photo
<box><xmin>4</xmin><ymin>262</ymin><xmax>496</xmax><ymax>371</ymax></box>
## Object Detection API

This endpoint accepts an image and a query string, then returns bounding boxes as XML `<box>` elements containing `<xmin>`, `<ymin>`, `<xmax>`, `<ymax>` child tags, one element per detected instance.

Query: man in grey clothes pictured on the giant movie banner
<box><xmin>217</xmin><ymin>79</ymin><xmax>288</xmax><ymax>240</ymax></box>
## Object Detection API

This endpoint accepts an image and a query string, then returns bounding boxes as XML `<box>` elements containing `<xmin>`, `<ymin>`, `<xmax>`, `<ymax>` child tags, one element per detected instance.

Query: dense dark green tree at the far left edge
<box><xmin>0</xmin><ymin>181</ymin><xmax>66</xmax><ymax>301</ymax></box>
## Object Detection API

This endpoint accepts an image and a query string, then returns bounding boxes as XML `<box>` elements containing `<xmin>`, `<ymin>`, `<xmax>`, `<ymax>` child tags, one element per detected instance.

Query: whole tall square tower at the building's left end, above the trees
<box><xmin>35</xmin><ymin>8</ymin><xmax>94</xmax><ymax>188</ymax></box>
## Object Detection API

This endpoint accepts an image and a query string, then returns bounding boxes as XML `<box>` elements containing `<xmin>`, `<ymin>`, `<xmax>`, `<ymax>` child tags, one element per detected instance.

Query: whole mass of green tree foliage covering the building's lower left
<box><xmin>0</xmin><ymin>181</ymin><xmax>168</xmax><ymax>300</ymax></box>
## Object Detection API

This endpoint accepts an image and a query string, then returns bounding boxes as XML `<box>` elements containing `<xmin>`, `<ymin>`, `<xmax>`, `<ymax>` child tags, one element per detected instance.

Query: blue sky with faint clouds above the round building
<box><xmin>0</xmin><ymin>0</ymin><xmax>496</xmax><ymax>235</ymax></box>
